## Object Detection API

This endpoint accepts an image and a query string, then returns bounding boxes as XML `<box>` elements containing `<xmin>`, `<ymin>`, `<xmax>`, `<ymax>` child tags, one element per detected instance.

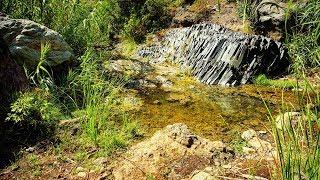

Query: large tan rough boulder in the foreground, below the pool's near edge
<box><xmin>113</xmin><ymin>123</ymin><xmax>234</xmax><ymax>180</ymax></box>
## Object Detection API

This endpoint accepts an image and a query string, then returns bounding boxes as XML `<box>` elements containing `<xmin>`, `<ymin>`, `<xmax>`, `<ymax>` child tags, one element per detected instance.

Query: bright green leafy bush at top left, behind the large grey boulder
<box><xmin>0</xmin><ymin>0</ymin><xmax>123</xmax><ymax>55</ymax></box>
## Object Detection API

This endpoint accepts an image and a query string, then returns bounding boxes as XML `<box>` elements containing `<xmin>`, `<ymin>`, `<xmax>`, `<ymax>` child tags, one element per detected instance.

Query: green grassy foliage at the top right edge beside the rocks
<box><xmin>286</xmin><ymin>0</ymin><xmax>320</xmax><ymax>75</ymax></box>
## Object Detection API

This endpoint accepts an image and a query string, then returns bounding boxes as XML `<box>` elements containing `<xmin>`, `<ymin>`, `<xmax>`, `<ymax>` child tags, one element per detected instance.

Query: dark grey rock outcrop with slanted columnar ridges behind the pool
<box><xmin>139</xmin><ymin>24</ymin><xmax>289</xmax><ymax>86</ymax></box>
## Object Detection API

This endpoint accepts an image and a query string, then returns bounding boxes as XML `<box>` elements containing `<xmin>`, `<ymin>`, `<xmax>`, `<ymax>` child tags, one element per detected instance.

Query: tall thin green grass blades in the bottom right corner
<box><xmin>270</xmin><ymin>82</ymin><xmax>320</xmax><ymax>179</ymax></box>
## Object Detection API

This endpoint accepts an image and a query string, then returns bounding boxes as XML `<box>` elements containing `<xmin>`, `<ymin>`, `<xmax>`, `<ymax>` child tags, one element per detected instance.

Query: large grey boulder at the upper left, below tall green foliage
<box><xmin>0</xmin><ymin>14</ymin><xmax>74</xmax><ymax>68</ymax></box>
